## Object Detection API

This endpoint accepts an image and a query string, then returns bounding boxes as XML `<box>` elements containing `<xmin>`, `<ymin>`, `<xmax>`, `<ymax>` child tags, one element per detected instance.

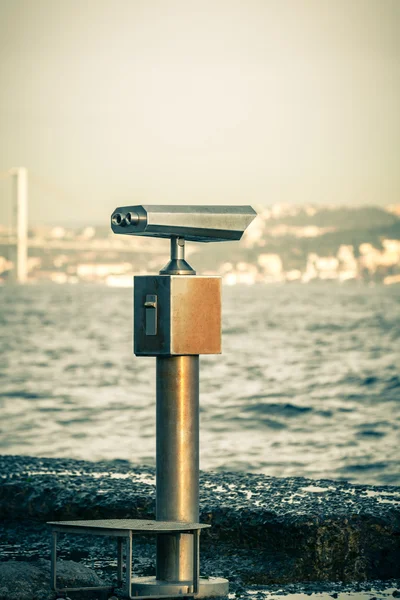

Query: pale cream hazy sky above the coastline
<box><xmin>0</xmin><ymin>0</ymin><xmax>400</xmax><ymax>223</ymax></box>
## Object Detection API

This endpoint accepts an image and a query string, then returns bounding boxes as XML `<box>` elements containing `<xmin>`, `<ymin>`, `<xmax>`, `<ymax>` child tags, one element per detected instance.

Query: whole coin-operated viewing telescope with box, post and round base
<box><xmin>111</xmin><ymin>205</ymin><xmax>256</xmax><ymax>598</ymax></box>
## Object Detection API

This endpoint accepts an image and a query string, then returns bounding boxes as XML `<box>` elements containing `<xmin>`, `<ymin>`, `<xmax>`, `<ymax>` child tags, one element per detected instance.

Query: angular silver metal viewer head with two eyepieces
<box><xmin>111</xmin><ymin>205</ymin><xmax>256</xmax><ymax>242</ymax></box>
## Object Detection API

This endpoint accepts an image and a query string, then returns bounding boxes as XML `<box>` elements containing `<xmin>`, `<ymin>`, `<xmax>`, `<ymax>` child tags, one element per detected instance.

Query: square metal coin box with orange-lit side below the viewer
<box><xmin>134</xmin><ymin>275</ymin><xmax>221</xmax><ymax>356</ymax></box>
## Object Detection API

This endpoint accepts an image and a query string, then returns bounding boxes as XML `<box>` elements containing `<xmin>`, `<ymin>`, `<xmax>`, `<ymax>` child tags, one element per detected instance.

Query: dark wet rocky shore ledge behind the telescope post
<box><xmin>0</xmin><ymin>456</ymin><xmax>400</xmax><ymax>600</ymax></box>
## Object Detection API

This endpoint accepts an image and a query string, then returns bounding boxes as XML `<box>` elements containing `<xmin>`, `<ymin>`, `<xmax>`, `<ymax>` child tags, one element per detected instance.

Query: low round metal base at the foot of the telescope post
<box><xmin>132</xmin><ymin>577</ymin><xmax>229</xmax><ymax>598</ymax></box>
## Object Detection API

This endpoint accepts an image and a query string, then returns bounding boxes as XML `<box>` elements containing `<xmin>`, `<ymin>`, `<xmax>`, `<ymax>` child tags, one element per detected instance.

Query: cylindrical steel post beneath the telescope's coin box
<box><xmin>156</xmin><ymin>356</ymin><xmax>199</xmax><ymax>582</ymax></box>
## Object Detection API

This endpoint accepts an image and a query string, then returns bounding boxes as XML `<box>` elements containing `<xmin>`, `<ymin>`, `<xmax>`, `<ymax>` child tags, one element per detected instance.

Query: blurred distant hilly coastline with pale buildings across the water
<box><xmin>0</xmin><ymin>204</ymin><xmax>400</xmax><ymax>287</ymax></box>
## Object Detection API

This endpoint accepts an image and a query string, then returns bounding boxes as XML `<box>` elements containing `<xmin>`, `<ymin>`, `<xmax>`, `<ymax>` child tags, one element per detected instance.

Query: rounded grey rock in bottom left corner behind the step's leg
<box><xmin>0</xmin><ymin>559</ymin><xmax>104</xmax><ymax>600</ymax></box>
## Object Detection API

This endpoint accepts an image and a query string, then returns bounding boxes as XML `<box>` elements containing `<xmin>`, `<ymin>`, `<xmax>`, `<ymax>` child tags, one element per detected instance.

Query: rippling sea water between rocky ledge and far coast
<box><xmin>0</xmin><ymin>284</ymin><xmax>400</xmax><ymax>485</ymax></box>
